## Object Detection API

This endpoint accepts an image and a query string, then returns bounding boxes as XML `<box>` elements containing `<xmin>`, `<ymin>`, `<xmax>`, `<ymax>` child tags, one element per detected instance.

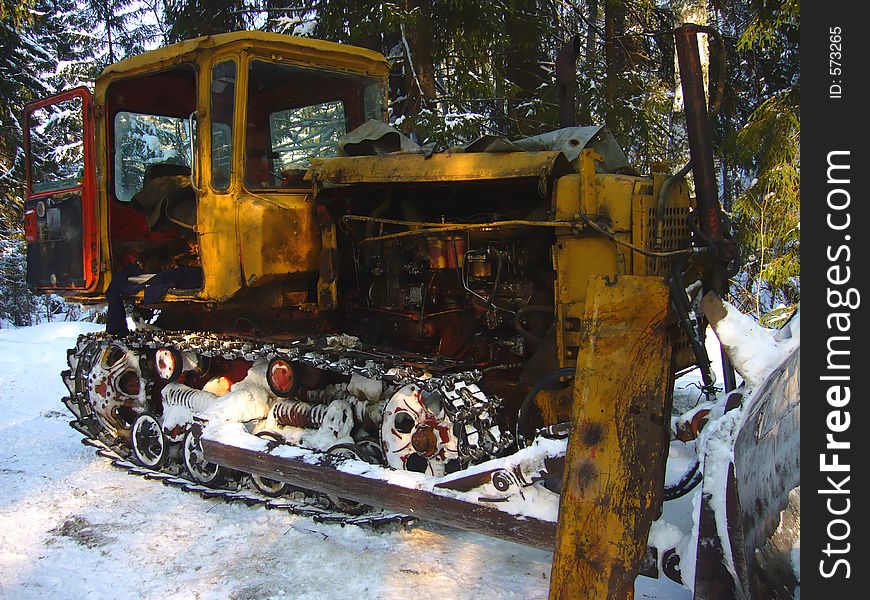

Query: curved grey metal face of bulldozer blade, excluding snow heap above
<box><xmin>695</xmin><ymin>347</ymin><xmax>800</xmax><ymax>600</ymax></box>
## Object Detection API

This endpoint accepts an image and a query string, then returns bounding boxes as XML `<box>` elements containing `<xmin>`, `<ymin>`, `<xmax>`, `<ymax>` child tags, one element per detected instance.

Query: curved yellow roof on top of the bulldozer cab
<box><xmin>100</xmin><ymin>31</ymin><xmax>389</xmax><ymax>79</ymax></box>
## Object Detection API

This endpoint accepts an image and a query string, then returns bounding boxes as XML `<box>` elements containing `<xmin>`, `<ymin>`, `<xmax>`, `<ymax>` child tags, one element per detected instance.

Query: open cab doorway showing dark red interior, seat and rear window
<box><xmin>106</xmin><ymin>64</ymin><xmax>200</xmax><ymax>284</ymax></box>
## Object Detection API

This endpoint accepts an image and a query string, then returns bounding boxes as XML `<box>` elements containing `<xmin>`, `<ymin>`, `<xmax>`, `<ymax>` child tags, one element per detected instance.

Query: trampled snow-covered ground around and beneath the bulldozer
<box><xmin>0</xmin><ymin>323</ymin><xmax>728</xmax><ymax>600</ymax></box>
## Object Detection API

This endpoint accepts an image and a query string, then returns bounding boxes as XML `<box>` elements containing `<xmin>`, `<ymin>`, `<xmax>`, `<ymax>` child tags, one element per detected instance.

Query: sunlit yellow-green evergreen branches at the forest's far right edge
<box><xmin>723</xmin><ymin>0</ymin><xmax>800</xmax><ymax>323</ymax></box>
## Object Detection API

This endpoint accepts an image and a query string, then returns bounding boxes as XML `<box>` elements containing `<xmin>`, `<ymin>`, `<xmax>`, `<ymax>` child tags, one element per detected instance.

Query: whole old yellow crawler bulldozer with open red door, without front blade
<box><xmin>25</xmin><ymin>27</ymin><xmax>796</xmax><ymax>598</ymax></box>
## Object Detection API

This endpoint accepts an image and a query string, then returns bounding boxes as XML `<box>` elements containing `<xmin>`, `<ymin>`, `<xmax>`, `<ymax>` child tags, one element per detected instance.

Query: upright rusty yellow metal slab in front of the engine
<box><xmin>550</xmin><ymin>276</ymin><xmax>671</xmax><ymax>600</ymax></box>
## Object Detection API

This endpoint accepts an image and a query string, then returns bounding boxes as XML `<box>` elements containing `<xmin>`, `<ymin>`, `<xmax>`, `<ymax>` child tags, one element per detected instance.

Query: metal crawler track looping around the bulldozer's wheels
<box><xmin>61</xmin><ymin>331</ymin><xmax>511</xmax><ymax>527</ymax></box>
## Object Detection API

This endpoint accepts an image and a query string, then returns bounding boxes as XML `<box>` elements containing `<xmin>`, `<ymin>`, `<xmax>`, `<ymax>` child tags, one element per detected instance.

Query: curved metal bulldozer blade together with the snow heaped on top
<box><xmin>694</xmin><ymin>292</ymin><xmax>800</xmax><ymax>600</ymax></box>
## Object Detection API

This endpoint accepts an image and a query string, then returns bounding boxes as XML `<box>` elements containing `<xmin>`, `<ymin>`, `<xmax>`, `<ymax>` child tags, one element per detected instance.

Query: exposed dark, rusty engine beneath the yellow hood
<box><xmin>345</xmin><ymin>207</ymin><xmax>553</xmax><ymax>366</ymax></box>
